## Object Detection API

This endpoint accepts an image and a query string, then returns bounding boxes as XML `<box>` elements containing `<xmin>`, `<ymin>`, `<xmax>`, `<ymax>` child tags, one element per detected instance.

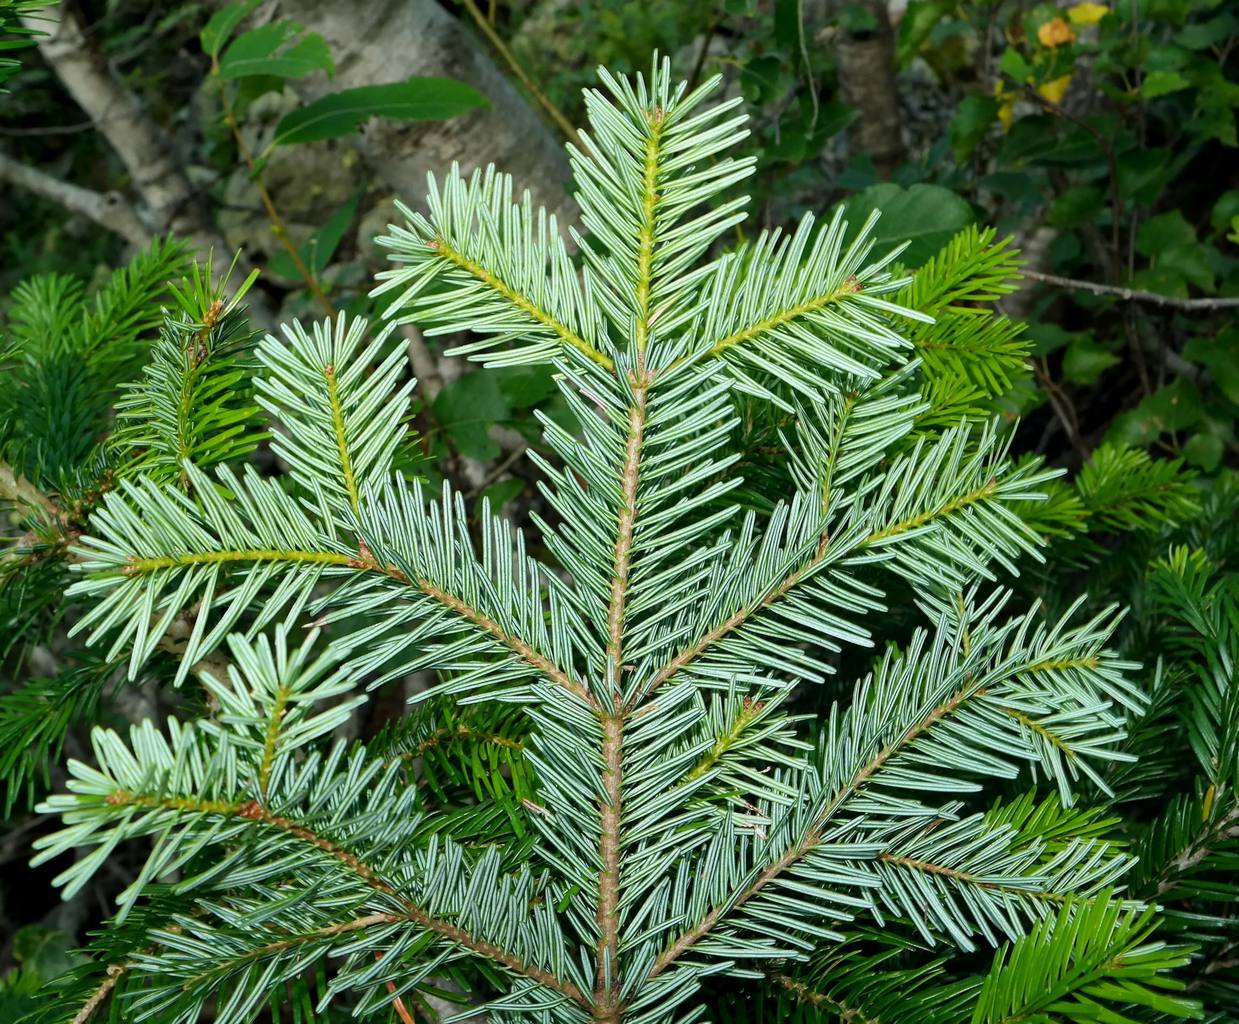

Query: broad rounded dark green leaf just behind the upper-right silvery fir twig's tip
<box><xmin>844</xmin><ymin>182</ymin><xmax>974</xmax><ymax>267</ymax></box>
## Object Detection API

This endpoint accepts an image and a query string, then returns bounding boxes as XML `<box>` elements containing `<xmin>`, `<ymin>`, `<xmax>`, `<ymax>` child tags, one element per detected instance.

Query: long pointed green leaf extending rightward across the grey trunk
<box><xmin>274</xmin><ymin>78</ymin><xmax>487</xmax><ymax>146</ymax></box>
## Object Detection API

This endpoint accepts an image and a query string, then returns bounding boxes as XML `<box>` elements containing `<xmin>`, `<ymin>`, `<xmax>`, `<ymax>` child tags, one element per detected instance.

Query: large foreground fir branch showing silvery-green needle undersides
<box><xmin>19</xmin><ymin>66</ymin><xmax>1208</xmax><ymax>1024</ymax></box>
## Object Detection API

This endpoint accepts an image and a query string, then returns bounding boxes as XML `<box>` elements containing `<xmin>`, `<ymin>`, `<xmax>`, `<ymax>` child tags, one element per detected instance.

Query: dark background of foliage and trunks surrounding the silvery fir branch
<box><xmin>0</xmin><ymin>0</ymin><xmax>1239</xmax><ymax>1022</ymax></box>
